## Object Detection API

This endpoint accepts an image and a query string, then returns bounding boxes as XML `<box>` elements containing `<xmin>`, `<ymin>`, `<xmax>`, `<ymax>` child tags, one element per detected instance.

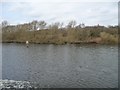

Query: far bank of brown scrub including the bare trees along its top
<box><xmin>0</xmin><ymin>21</ymin><xmax>119</xmax><ymax>44</ymax></box>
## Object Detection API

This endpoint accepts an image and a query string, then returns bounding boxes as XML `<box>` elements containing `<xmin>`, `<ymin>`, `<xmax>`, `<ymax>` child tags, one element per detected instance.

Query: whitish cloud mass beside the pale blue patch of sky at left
<box><xmin>6</xmin><ymin>2</ymin><xmax>118</xmax><ymax>25</ymax></box>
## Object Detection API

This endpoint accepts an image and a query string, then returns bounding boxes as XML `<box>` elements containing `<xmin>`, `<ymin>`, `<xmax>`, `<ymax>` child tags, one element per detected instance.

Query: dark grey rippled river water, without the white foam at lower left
<box><xmin>2</xmin><ymin>44</ymin><xmax>118</xmax><ymax>88</ymax></box>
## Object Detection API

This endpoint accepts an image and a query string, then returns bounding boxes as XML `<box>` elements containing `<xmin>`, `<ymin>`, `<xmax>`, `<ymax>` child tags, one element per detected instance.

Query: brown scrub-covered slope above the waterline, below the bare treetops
<box><xmin>2</xmin><ymin>28</ymin><xmax>119</xmax><ymax>44</ymax></box>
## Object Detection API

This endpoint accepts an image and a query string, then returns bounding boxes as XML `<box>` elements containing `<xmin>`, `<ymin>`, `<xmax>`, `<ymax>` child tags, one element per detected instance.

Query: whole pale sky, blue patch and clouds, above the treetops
<box><xmin>0</xmin><ymin>0</ymin><xmax>119</xmax><ymax>26</ymax></box>
